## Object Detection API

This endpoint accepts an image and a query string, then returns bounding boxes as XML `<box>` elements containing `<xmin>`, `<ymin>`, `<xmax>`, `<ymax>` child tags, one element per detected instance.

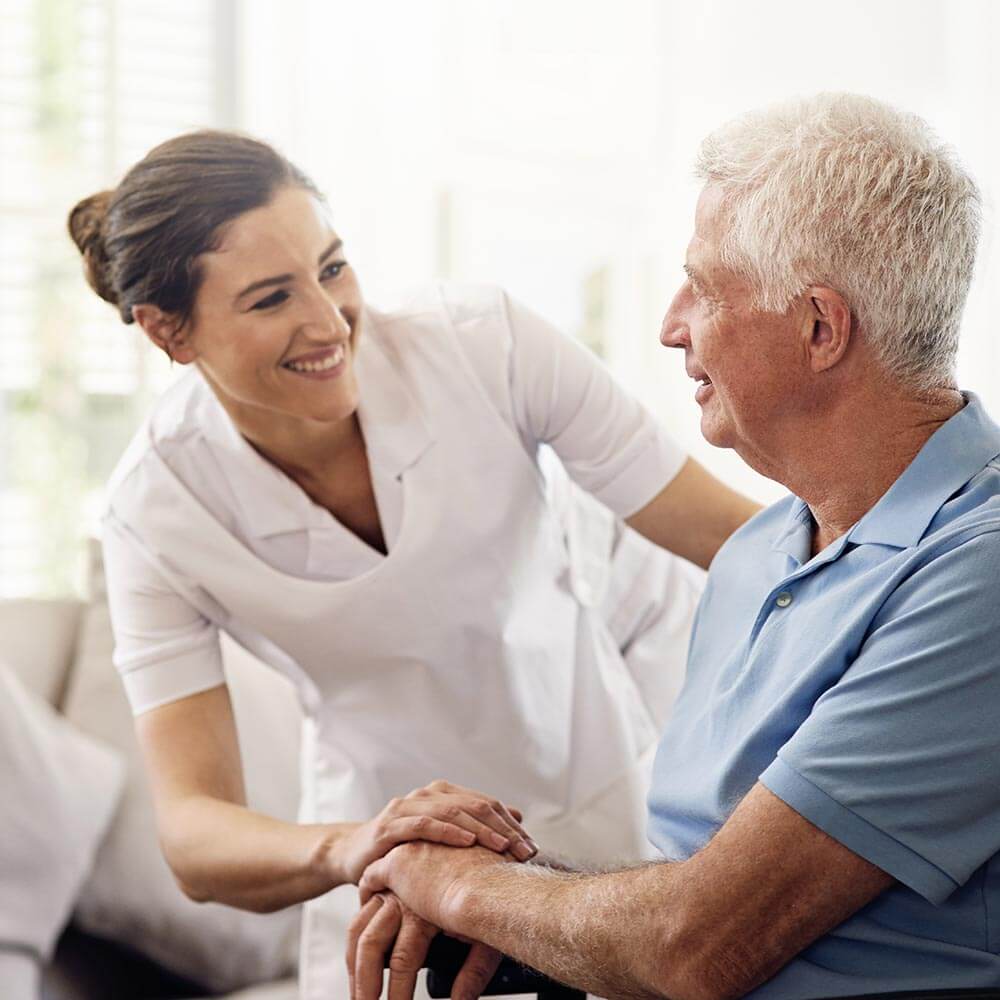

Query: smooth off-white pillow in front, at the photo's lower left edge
<box><xmin>0</xmin><ymin>664</ymin><xmax>123</xmax><ymax>980</ymax></box>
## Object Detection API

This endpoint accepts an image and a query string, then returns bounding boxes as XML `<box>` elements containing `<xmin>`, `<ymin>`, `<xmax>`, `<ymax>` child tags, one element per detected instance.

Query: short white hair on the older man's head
<box><xmin>696</xmin><ymin>94</ymin><xmax>980</xmax><ymax>389</ymax></box>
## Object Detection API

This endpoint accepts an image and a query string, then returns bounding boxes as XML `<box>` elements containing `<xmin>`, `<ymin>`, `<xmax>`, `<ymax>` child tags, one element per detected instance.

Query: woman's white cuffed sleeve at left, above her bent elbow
<box><xmin>103</xmin><ymin>514</ymin><xmax>225</xmax><ymax>715</ymax></box>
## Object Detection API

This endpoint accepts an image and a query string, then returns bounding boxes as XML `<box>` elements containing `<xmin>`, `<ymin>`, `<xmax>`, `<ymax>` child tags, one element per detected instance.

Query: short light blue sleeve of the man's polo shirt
<box><xmin>761</xmin><ymin>530</ymin><xmax>1000</xmax><ymax>903</ymax></box>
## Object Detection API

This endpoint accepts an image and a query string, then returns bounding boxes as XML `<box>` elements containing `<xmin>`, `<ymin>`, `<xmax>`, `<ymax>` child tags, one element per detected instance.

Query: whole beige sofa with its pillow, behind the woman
<box><xmin>0</xmin><ymin>545</ymin><xmax>301</xmax><ymax>1000</ymax></box>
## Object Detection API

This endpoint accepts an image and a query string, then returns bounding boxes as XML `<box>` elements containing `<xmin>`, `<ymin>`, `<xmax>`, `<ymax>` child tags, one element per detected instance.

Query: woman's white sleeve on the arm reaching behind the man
<box><xmin>504</xmin><ymin>296</ymin><xmax>687</xmax><ymax>517</ymax></box>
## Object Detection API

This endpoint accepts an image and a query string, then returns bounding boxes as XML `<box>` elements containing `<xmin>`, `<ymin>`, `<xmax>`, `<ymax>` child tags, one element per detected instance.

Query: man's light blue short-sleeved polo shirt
<box><xmin>649</xmin><ymin>393</ymin><xmax>1000</xmax><ymax>1000</ymax></box>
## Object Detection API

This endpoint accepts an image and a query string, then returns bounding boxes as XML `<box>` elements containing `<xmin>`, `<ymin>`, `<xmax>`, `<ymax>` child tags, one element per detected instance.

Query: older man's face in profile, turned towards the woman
<box><xmin>660</xmin><ymin>186</ymin><xmax>808</xmax><ymax>460</ymax></box>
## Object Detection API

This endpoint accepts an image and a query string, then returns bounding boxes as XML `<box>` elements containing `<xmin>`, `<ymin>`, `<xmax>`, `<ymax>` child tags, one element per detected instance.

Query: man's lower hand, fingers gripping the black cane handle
<box><xmin>347</xmin><ymin>892</ymin><xmax>501</xmax><ymax>1000</ymax></box>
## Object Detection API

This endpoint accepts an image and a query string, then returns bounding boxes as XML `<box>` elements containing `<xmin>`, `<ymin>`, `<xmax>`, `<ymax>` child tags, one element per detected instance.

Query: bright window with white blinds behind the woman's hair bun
<box><xmin>0</xmin><ymin>0</ymin><xmax>236</xmax><ymax>597</ymax></box>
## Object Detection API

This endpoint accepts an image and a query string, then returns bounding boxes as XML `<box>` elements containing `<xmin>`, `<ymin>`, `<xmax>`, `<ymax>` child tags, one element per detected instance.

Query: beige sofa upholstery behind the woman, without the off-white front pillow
<box><xmin>0</xmin><ymin>563</ymin><xmax>301</xmax><ymax>1000</ymax></box>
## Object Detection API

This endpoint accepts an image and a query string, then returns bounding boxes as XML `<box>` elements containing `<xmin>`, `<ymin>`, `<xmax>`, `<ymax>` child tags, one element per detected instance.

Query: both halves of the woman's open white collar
<box><xmin>193</xmin><ymin>309</ymin><xmax>433</xmax><ymax>538</ymax></box>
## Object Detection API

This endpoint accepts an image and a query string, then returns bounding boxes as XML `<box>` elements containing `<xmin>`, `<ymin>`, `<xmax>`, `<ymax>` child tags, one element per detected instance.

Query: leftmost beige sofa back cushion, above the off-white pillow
<box><xmin>0</xmin><ymin>600</ymin><xmax>83</xmax><ymax>706</ymax></box>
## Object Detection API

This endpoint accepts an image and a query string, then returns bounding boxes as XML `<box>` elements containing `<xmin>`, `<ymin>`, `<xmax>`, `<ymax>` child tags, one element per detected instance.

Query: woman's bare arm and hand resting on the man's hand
<box><xmin>136</xmin><ymin>685</ymin><xmax>537</xmax><ymax>913</ymax></box>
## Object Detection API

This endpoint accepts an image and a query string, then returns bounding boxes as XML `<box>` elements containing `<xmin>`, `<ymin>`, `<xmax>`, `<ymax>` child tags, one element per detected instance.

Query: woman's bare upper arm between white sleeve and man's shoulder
<box><xmin>625</xmin><ymin>458</ymin><xmax>760</xmax><ymax>569</ymax></box>
